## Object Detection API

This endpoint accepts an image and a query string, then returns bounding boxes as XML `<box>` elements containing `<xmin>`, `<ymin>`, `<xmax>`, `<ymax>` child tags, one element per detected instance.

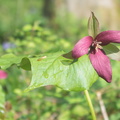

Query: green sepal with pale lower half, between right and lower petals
<box><xmin>103</xmin><ymin>44</ymin><xmax>120</xmax><ymax>61</ymax></box>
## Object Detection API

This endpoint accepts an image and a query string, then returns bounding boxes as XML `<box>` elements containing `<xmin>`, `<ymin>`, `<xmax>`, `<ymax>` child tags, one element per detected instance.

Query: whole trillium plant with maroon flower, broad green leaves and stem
<box><xmin>0</xmin><ymin>12</ymin><xmax>120</xmax><ymax>120</ymax></box>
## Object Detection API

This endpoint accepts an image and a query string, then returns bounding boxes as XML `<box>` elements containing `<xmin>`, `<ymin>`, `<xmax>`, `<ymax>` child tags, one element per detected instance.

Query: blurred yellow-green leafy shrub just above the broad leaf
<box><xmin>7</xmin><ymin>22</ymin><xmax>71</xmax><ymax>55</ymax></box>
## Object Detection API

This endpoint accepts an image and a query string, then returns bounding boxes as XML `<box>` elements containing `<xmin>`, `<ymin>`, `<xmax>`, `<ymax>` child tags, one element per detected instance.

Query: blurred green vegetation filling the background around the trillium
<box><xmin>0</xmin><ymin>0</ymin><xmax>120</xmax><ymax>120</ymax></box>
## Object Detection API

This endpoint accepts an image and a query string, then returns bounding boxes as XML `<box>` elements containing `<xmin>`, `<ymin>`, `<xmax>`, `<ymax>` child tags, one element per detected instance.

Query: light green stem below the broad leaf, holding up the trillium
<box><xmin>84</xmin><ymin>90</ymin><xmax>96</xmax><ymax>120</ymax></box>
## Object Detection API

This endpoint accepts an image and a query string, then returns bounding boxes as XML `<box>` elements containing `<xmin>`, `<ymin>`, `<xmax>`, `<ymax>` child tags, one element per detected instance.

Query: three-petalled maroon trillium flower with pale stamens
<box><xmin>72</xmin><ymin>30</ymin><xmax>120</xmax><ymax>82</ymax></box>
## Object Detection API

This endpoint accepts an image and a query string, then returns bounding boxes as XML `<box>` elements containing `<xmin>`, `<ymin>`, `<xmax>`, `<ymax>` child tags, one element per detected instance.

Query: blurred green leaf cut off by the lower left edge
<box><xmin>0</xmin><ymin>86</ymin><xmax>5</xmax><ymax>120</ymax></box>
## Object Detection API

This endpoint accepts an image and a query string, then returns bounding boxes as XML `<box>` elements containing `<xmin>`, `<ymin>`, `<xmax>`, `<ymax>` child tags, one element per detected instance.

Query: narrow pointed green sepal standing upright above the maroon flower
<box><xmin>88</xmin><ymin>12</ymin><xmax>99</xmax><ymax>38</ymax></box>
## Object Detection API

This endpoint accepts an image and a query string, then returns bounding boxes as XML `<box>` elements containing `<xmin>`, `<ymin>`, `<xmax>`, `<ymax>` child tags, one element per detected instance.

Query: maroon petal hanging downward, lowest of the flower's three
<box><xmin>89</xmin><ymin>49</ymin><xmax>112</xmax><ymax>82</ymax></box>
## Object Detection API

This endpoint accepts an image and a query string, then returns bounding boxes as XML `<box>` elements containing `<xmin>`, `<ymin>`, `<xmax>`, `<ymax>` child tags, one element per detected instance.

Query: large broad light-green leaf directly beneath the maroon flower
<box><xmin>25</xmin><ymin>53</ymin><xmax>98</xmax><ymax>92</ymax></box>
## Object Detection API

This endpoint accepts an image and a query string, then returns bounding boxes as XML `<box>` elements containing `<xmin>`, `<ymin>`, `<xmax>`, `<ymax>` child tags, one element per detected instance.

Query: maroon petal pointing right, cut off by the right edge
<box><xmin>95</xmin><ymin>30</ymin><xmax>120</xmax><ymax>45</ymax></box>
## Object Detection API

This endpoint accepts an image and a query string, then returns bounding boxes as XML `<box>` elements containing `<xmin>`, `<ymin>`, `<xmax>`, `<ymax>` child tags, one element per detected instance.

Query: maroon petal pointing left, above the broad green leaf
<box><xmin>72</xmin><ymin>36</ymin><xmax>93</xmax><ymax>58</ymax></box>
